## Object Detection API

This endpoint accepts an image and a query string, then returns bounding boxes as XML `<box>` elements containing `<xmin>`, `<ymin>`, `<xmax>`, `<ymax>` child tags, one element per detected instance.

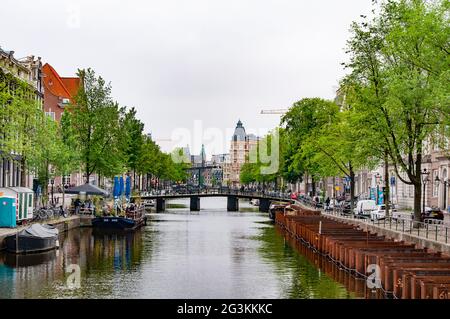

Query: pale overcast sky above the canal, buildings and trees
<box><xmin>0</xmin><ymin>0</ymin><xmax>371</xmax><ymax>155</ymax></box>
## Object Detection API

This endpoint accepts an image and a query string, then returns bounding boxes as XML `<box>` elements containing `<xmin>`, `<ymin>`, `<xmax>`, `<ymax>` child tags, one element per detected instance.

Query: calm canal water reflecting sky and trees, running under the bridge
<box><xmin>0</xmin><ymin>198</ymin><xmax>373</xmax><ymax>299</ymax></box>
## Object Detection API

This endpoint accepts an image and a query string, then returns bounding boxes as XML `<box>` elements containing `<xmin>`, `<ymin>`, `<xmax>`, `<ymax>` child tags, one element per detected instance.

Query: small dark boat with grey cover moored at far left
<box><xmin>5</xmin><ymin>224</ymin><xmax>59</xmax><ymax>254</ymax></box>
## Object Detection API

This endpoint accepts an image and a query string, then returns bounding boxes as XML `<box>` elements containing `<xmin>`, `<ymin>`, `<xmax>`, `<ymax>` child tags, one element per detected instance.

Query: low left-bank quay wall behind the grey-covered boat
<box><xmin>0</xmin><ymin>216</ymin><xmax>92</xmax><ymax>251</ymax></box>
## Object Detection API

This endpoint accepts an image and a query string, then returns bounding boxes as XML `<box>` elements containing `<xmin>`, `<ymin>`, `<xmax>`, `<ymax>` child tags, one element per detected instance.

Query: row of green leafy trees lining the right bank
<box><xmin>242</xmin><ymin>0</ymin><xmax>450</xmax><ymax>219</ymax></box>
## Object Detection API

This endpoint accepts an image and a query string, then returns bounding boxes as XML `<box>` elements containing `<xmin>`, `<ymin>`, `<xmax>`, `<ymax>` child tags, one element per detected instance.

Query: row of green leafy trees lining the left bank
<box><xmin>0</xmin><ymin>69</ymin><xmax>187</xmax><ymax>202</ymax></box>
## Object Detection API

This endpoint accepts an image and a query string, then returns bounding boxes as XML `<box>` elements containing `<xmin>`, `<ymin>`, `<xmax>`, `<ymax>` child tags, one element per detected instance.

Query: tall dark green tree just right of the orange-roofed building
<box><xmin>64</xmin><ymin>69</ymin><xmax>126</xmax><ymax>183</ymax></box>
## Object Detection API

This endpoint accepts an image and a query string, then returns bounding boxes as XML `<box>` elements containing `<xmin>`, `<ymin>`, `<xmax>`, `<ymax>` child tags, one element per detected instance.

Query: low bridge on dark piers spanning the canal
<box><xmin>135</xmin><ymin>188</ymin><xmax>291</xmax><ymax>212</ymax></box>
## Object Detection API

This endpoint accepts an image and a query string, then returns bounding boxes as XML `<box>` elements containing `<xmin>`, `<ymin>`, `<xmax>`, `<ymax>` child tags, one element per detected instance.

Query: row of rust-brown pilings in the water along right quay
<box><xmin>275</xmin><ymin>205</ymin><xmax>450</xmax><ymax>299</ymax></box>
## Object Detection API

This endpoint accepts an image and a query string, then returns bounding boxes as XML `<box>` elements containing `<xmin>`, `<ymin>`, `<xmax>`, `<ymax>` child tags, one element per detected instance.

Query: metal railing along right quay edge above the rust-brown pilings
<box><xmin>299</xmin><ymin>199</ymin><xmax>450</xmax><ymax>244</ymax></box>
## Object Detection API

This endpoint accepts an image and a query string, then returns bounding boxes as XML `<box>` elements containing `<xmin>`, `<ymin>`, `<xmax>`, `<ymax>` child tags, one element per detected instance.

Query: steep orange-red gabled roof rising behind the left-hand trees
<box><xmin>42</xmin><ymin>63</ymin><xmax>79</xmax><ymax>98</ymax></box>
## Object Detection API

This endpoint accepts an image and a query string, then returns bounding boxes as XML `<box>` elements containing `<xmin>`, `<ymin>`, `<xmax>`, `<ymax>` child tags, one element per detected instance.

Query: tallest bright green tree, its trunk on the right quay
<box><xmin>344</xmin><ymin>0</ymin><xmax>450</xmax><ymax>220</ymax></box>
